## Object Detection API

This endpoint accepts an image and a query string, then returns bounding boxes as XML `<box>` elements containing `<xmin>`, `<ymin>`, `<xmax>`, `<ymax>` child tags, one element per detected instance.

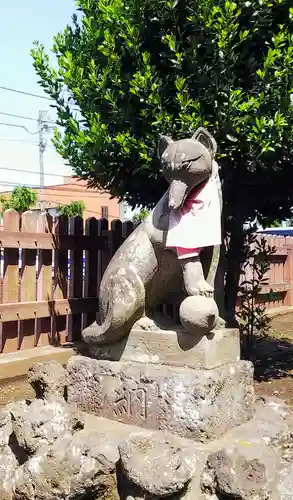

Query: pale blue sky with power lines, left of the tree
<box><xmin>0</xmin><ymin>0</ymin><xmax>76</xmax><ymax>191</ymax></box>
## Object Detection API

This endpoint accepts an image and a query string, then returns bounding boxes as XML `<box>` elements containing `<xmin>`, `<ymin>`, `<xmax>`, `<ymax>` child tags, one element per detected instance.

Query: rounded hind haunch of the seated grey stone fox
<box><xmin>82</xmin><ymin>267</ymin><xmax>145</xmax><ymax>344</ymax></box>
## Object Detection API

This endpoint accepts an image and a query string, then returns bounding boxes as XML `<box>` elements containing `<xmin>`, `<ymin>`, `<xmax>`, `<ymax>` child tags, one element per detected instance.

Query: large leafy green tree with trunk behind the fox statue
<box><xmin>32</xmin><ymin>0</ymin><xmax>293</xmax><ymax>320</ymax></box>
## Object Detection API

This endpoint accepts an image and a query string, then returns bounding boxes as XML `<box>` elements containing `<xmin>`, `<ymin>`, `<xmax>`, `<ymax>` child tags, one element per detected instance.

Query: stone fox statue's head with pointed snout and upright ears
<box><xmin>158</xmin><ymin>128</ymin><xmax>217</xmax><ymax>210</ymax></box>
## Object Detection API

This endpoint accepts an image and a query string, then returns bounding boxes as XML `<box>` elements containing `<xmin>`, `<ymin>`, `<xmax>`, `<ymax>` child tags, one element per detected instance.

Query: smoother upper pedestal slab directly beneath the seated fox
<box><xmin>85</xmin><ymin>328</ymin><xmax>240</xmax><ymax>370</ymax></box>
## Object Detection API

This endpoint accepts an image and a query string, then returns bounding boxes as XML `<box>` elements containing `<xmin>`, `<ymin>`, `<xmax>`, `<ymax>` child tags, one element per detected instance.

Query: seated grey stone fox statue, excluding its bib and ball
<box><xmin>83</xmin><ymin>128</ymin><xmax>222</xmax><ymax>344</ymax></box>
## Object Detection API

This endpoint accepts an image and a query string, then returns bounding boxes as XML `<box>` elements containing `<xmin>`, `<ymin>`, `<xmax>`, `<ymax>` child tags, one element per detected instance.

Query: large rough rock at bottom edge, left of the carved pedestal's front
<box><xmin>13</xmin><ymin>434</ymin><xmax>119</xmax><ymax>500</ymax></box>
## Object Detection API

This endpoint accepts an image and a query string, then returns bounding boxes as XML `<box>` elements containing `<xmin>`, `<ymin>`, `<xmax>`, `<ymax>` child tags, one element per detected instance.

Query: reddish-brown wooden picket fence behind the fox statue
<box><xmin>0</xmin><ymin>210</ymin><xmax>293</xmax><ymax>353</ymax></box>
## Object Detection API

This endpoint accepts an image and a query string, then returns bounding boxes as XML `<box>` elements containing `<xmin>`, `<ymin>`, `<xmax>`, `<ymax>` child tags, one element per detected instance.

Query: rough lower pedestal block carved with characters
<box><xmin>67</xmin><ymin>356</ymin><xmax>254</xmax><ymax>442</ymax></box>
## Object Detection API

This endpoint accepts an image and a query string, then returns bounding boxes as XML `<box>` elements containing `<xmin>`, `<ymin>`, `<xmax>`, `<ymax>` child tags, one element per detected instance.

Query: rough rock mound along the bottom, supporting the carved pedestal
<box><xmin>0</xmin><ymin>363</ymin><xmax>293</xmax><ymax>500</ymax></box>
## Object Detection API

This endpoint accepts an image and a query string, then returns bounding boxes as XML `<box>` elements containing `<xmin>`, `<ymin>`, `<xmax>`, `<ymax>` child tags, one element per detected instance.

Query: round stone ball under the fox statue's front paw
<box><xmin>179</xmin><ymin>295</ymin><xmax>219</xmax><ymax>336</ymax></box>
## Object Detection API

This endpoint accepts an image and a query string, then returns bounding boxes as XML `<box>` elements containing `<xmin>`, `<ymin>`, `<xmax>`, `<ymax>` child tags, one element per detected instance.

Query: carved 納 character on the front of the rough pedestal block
<box><xmin>113</xmin><ymin>384</ymin><xmax>147</xmax><ymax>420</ymax></box>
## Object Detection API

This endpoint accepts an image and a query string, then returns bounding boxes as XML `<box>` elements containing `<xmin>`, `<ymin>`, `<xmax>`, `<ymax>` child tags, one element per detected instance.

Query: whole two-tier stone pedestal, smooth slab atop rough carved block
<box><xmin>68</xmin><ymin>329</ymin><xmax>254</xmax><ymax>442</ymax></box>
